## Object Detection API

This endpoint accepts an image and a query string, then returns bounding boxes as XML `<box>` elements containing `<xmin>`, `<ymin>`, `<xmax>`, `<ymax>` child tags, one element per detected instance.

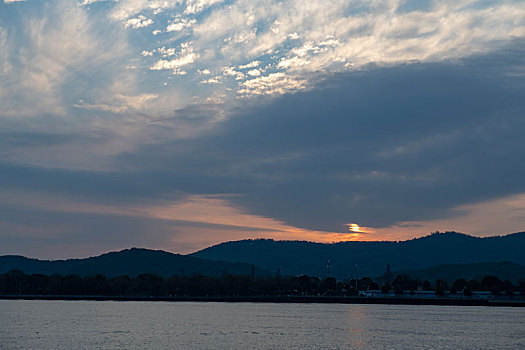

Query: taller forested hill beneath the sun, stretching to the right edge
<box><xmin>192</xmin><ymin>232</ymin><xmax>525</xmax><ymax>278</ymax></box>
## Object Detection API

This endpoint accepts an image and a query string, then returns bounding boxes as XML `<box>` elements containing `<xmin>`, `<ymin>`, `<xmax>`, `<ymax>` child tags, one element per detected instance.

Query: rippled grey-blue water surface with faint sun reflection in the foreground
<box><xmin>0</xmin><ymin>300</ymin><xmax>525</xmax><ymax>349</ymax></box>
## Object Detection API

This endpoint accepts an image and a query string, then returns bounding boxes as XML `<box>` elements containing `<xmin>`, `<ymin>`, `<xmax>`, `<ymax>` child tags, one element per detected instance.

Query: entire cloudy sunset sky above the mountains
<box><xmin>0</xmin><ymin>0</ymin><xmax>525</xmax><ymax>259</ymax></box>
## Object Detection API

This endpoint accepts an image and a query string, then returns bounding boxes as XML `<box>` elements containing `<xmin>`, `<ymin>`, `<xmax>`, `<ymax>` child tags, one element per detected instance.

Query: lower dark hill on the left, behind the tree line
<box><xmin>0</xmin><ymin>248</ymin><xmax>268</xmax><ymax>277</ymax></box>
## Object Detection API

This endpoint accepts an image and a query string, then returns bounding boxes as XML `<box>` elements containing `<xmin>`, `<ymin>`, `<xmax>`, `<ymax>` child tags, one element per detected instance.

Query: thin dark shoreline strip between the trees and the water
<box><xmin>0</xmin><ymin>295</ymin><xmax>525</xmax><ymax>307</ymax></box>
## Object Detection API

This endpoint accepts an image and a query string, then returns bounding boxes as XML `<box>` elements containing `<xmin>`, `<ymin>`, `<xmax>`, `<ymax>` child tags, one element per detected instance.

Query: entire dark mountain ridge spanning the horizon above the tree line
<box><xmin>0</xmin><ymin>231</ymin><xmax>525</xmax><ymax>279</ymax></box>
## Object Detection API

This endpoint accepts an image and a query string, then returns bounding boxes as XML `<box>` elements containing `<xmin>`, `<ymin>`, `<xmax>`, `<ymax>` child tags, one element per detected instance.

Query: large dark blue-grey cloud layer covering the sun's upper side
<box><xmin>0</xmin><ymin>42</ymin><xmax>525</xmax><ymax>239</ymax></box>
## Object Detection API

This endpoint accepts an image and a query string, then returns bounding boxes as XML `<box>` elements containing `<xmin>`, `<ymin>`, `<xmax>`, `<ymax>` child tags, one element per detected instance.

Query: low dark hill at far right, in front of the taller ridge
<box><xmin>393</xmin><ymin>261</ymin><xmax>525</xmax><ymax>283</ymax></box>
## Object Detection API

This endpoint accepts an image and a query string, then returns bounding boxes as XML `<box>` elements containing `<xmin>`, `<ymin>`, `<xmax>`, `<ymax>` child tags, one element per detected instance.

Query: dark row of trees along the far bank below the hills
<box><xmin>0</xmin><ymin>270</ymin><xmax>525</xmax><ymax>296</ymax></box>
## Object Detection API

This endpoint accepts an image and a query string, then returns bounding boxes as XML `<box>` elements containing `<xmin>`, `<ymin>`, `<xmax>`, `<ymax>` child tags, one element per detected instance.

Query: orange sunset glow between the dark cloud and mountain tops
<box><xmin>4</xmin><ymin>190</ymin><xmax>525</xmax><ymax>257</ymax></box>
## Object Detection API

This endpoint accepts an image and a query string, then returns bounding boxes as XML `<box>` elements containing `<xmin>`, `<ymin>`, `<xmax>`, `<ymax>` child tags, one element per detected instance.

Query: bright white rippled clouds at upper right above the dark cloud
<box><xmin>185</xmin><ymin>0</ymin><xmax>525</xmax><ymax>94</ymax></box>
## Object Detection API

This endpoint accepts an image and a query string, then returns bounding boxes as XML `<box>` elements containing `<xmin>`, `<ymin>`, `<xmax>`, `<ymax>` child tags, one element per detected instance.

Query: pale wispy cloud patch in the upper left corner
<box><xmin>0</xmin><ymin>1</ymin><xmax>131</xmax><ymax>118</ymax></box>
